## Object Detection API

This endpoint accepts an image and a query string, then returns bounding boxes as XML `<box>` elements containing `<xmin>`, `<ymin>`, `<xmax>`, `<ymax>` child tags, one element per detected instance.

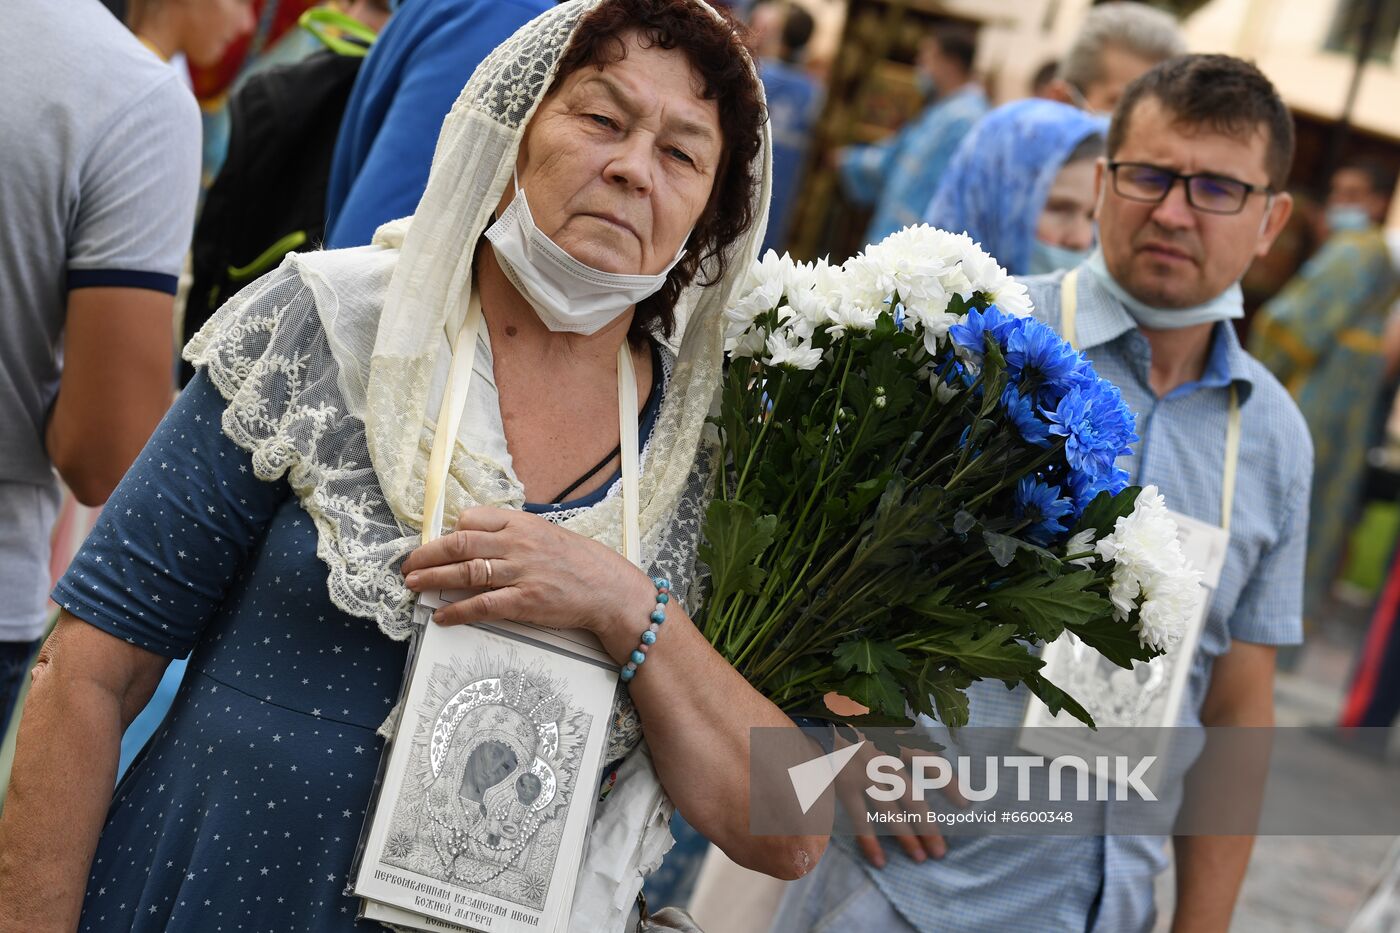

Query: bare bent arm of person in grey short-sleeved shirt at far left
<box><xmin>45</xmin><ymin>287</ymin><xmax>175</xmax><ymax>506</ymax></box>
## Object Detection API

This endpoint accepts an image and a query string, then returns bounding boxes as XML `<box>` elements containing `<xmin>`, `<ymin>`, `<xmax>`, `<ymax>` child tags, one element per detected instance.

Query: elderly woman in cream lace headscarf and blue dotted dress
<box><xmin>0</xmin><ymin>0</ymin><xmax>825</xmax><ymax>933</ymax></box>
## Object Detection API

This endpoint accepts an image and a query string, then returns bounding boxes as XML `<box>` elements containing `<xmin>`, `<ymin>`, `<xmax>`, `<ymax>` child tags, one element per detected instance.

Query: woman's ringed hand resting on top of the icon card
<box><xmin>402</xmin><ymin>506</ymin><xmax>655</xmax><ymax>637</ymax></box>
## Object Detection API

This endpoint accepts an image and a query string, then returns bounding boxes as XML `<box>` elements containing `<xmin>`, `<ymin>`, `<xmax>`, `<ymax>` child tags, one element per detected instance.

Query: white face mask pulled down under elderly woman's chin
<box><xmin>486</xmin><ymin>174</ymin><xmax>689</xmax><ymax>335</ymax></box>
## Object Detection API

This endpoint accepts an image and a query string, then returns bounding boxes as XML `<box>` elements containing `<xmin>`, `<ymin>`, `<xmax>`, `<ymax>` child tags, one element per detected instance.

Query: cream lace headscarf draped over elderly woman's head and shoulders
<box><xmin>185</xmin><ymin>0</ymin><xmax>771</xmax><ymax>639</ymax></box>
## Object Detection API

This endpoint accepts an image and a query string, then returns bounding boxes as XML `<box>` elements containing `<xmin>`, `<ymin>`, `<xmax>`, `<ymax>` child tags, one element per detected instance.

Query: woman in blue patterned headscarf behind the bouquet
<box><xmin>924</xmin><ymin>99</ymin><xmax>1107</xmax><ymax>275</ymax></box>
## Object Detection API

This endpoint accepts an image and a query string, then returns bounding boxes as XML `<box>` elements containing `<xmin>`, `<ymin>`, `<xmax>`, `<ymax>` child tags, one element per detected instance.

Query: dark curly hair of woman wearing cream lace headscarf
<box><xmin>550</xmin><ymin>0</ymin><xmax>767</xmax><ymax>343</ymax></box>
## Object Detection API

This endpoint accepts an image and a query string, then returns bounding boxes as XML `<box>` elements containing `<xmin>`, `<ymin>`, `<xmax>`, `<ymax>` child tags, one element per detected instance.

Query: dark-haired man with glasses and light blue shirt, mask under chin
<box><xmin>773</xmin><ymin>55</ymin><xmax>1312</xmax><ymax>933</ymax></box>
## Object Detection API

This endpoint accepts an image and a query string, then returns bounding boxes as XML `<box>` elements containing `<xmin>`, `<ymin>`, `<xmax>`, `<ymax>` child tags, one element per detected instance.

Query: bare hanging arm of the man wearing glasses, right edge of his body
<box><xmin>1172</xmin><ymin>642</ymin><xmax>1277</xmax><ymax>933</ymax></box>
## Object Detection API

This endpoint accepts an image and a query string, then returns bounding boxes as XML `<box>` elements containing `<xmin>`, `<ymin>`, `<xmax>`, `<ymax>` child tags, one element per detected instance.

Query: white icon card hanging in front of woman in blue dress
<box><xmin>354</xmin><ymin>610</ymin><xmax>617</xmax><ymax>933</ymax></box>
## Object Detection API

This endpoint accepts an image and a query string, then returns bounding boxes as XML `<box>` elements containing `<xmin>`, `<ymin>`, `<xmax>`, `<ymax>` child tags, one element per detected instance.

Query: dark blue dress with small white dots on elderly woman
<box><xmin>53</xmin><ymin>358</ymin><xmax>661</xmax><ymax>933</ymax></box>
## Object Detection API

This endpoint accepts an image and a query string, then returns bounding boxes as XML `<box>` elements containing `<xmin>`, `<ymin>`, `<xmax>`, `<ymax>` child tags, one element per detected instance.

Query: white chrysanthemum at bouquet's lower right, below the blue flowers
<box><xmin>1096</xmin><ymin>486</ymin><xmax>1204</xmax><ymax>651</ymax></box>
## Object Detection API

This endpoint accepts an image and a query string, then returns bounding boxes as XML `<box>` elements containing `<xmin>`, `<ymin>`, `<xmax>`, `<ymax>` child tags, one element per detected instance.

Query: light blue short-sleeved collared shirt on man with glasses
<box><xmin>857</xmin><ymin>269</ymin><xmax>1312</xmax><ymax>933</ymax></box>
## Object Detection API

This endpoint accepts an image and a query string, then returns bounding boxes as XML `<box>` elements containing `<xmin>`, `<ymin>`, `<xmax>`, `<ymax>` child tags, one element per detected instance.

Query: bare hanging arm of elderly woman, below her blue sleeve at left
<box><xmin>0</xmin><ymin>612</ymin><xmax>167</xmax><ymax>933</ymax></box>
